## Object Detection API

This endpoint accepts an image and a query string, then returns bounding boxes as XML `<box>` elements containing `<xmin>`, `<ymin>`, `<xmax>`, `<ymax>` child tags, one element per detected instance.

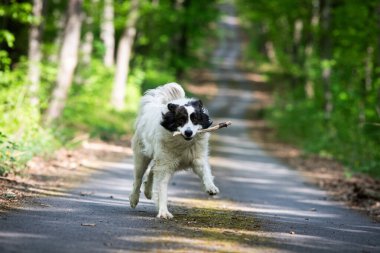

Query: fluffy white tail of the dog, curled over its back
<box><xmin>141</xmin><ymin>83</ymin><xmax>185</xmax><ymax>106</ymax></box>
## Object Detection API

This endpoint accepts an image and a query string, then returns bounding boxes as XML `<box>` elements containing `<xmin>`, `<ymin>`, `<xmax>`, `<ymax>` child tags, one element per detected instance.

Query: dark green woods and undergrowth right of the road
<box><xmin>237</xmin><ymin>0</ymin><xmax>380</xmax><ymax>177</ymax></box>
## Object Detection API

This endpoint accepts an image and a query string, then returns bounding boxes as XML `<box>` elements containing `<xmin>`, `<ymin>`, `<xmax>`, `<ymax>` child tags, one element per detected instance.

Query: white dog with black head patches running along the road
<box><xmin>129</xmin><ymin>83</ymin><xmax>219</xmax><ymax>219</ymax></box>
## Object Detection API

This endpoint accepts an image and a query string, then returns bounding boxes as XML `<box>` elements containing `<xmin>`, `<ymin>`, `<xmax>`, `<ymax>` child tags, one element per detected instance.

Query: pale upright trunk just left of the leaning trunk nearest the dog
<box><xmin>101</xmin><ymin>0</ymin><xmax>115</xmax><ymax>67</ymax></box>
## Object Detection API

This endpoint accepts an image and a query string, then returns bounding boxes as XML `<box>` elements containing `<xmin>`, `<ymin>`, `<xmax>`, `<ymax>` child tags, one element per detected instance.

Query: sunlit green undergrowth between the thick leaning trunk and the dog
<box><xmin>60</xmin><ymin>60</ymin><xmax>141</xmax><ymax>140</ymax></box>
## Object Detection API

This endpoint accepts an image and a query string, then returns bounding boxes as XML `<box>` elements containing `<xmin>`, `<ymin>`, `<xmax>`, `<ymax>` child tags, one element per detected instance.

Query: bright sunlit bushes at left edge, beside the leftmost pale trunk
<box><xmin>0</xmin><ymin>59</ymin><xmax>59</xmax><ymax>175</ymax></box>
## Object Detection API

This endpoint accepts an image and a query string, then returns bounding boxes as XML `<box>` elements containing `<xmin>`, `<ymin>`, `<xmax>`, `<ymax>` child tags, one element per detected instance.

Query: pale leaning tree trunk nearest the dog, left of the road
<box><xmin>111</xmin><ymin>0</ymin><xmax>139</xmax><ymax>110</ymax></box>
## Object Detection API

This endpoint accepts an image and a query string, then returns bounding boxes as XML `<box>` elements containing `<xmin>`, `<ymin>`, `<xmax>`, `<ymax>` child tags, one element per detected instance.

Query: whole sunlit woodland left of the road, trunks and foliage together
<box><xmin>0</xmin><ymin>0</ymin><xmax>218</xmax><ymax>175</ymax></box>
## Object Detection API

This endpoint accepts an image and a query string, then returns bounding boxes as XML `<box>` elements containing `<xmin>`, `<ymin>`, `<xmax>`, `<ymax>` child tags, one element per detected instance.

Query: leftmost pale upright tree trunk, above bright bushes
<box><xmin>28</xmin><ymin>0</ymin><xmax>43</xmax><ymax>106</ymax></box>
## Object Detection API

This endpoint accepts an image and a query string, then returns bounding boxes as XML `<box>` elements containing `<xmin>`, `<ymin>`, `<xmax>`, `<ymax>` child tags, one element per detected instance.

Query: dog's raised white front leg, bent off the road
<box><xmin>192</xmin><ymin>159</ymin><xmax>219</xmax><ymax>195</ymax></box>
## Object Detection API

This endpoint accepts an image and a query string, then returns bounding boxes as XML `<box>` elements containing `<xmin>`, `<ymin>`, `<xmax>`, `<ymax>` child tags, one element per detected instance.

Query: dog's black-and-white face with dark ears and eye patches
<box><xmin>161</xmin><ymin>100</ymin><xmax>212</xmax><ymax>141</ymax></box>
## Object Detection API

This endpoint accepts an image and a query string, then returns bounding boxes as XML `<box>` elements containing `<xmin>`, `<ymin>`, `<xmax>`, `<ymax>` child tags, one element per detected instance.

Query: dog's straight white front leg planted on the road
<box><xmin>153</xmin><ymin>167</ymin><xmax>173</xmax><ymax>219</ymax></box>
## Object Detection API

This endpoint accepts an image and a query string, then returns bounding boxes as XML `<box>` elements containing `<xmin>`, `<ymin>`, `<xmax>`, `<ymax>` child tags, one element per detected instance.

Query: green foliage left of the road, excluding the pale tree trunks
<box><xmin>0</xmin><ymin>0</ymin><xmax>217</xmax><ymax>175</ymax></box>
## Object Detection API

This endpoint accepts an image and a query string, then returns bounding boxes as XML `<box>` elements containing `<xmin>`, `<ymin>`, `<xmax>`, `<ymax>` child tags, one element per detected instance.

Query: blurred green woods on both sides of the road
<box><xmin>0</xmin><ymin>0</ymin><xmax>380</xmax><ymax>180</ymax></box>
